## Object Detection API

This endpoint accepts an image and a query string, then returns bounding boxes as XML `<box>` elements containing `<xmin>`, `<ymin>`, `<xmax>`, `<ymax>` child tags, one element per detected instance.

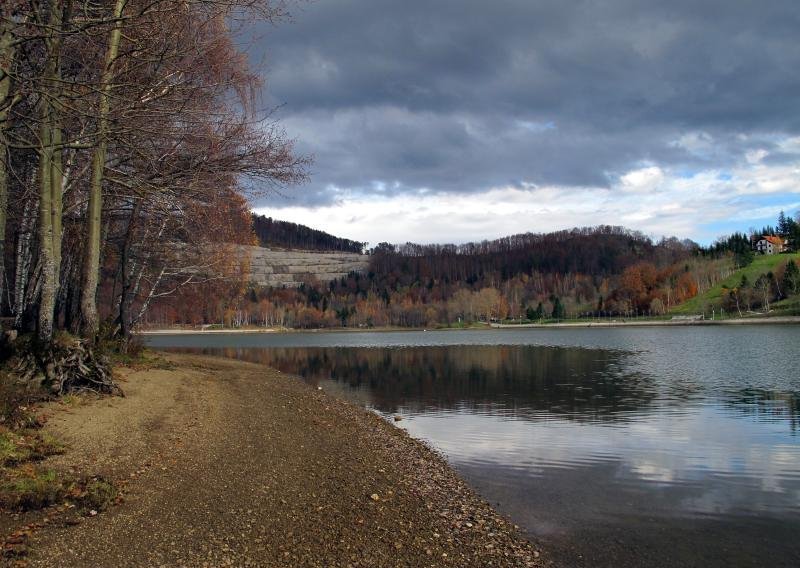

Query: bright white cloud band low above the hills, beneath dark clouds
<box><xmin>257</xmin><ymin>149</ymin><xmax>800</xmax><ymax>245</ymax></box>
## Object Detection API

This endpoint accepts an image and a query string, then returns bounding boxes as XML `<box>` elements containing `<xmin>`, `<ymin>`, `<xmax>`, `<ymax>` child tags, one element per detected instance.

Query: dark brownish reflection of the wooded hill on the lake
<box><xmin>173</xmin><ymin>346</ymin><xmax>656</xmax><ymax>421</ymax></box>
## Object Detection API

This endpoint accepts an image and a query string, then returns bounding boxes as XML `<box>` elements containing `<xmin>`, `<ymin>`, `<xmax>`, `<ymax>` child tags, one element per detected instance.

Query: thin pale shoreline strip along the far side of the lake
<box><xmin>137</xmin><ymin>316</ymin><xmax>800</xmax><ymax>335</ymax></box>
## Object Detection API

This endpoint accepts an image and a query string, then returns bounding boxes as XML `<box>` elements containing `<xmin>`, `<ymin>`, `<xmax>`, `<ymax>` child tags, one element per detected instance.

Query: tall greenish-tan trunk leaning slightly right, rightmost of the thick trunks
<box><xmin>81</xmin><ymin>0</ymin><xmax>126</xmax><ymax>338</ymax></box>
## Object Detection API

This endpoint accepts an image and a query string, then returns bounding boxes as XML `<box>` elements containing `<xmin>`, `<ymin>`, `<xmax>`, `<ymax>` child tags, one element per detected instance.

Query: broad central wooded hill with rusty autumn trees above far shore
<box><xmin>145</xmin><ymin>226</ymin><xmax>732</xmax><ymax>328</ymax></box>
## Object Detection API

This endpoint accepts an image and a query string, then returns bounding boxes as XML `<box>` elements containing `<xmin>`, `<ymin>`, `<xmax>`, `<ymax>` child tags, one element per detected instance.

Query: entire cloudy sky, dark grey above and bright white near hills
<box><xmin>250</xmin><ymin>0</ymin><xmax>800</xmax><ymax>244</ymax></box>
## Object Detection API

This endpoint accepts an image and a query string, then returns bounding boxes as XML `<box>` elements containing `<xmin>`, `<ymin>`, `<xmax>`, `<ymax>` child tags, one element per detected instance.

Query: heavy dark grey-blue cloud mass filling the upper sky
<box><xmin>247</xmin><ymin>0</ymin><xmax>800</xmax><ymax>205</ymax></box>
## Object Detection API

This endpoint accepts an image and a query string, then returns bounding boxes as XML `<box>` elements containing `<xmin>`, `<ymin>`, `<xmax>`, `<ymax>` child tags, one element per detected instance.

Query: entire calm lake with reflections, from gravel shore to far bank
<box><xmin>147</xmin><ymin>325</ymin><xmax>800</xmax><ymax>567</ymax></box>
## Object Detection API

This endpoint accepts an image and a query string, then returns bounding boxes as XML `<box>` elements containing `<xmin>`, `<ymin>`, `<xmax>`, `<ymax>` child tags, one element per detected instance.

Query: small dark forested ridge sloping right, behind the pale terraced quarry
<box><xmin>253</xmin><ymin>215</ymin><xmax>366</xmax><ymax>253</ymax></box>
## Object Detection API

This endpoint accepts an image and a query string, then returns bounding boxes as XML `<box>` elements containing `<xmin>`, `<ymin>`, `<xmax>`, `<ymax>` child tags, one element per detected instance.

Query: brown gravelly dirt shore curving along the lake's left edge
<box><xmin>17</xmin><ymin>355</ymin><xmax>540</xmax><ymax>567</ymax></box>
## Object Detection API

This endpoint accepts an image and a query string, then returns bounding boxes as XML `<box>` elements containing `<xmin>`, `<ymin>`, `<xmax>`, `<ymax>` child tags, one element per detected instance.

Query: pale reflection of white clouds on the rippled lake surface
<box><xmin>403</xmin><ymin>406</ymin><xmax>800</xmax><ymax>515</ymax></box>
